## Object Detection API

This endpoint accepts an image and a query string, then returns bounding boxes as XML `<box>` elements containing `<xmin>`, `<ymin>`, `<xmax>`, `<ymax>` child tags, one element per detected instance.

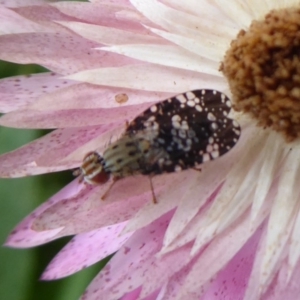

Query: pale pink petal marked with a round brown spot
<box><xmin>28</xmin><ymin>83</ymin><xmax>174</xmax><ymax>111</ymax></box>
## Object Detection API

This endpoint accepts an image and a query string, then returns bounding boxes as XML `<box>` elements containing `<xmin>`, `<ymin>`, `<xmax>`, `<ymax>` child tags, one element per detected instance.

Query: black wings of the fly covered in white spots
<box><xmin>126</xmin><ymin>90</ymin><xmax>240</xmax><ymax>174</ymax></box>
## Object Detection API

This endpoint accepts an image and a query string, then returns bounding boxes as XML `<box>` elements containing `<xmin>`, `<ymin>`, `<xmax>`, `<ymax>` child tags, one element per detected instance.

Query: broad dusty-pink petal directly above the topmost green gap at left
<box><xmin>0</xmin><ymin>32</ymin><xmax>132</xmax><ymax>75</ymax></box>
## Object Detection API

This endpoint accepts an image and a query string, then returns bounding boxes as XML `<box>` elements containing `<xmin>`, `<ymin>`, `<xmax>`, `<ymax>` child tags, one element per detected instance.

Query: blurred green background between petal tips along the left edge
<box><xmin>0</xmin><ymin>61</ymin><xmax>107</xmax><ymax>300</ymax></box>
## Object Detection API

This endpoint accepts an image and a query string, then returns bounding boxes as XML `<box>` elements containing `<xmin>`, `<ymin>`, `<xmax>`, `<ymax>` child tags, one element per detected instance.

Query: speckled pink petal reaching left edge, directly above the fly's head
<box><xmin>0</xmin><ymin>124</ymin><xmax>119</xmax><ymax>177</ymax></box>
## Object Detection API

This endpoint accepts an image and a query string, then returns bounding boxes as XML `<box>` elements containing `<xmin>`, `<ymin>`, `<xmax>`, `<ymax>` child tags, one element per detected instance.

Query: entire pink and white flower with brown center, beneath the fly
<box><xmin>0</xmin><ymin>0</ymin><xmax>300</xmax><ymax>300</ymax></box>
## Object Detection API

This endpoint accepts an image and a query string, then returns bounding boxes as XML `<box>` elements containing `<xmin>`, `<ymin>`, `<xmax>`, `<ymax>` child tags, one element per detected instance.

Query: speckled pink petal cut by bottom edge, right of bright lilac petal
<box><xmin>82</xmin><ymin>212</ymin><xmax>173</xmax><ymax>300</ymax></box>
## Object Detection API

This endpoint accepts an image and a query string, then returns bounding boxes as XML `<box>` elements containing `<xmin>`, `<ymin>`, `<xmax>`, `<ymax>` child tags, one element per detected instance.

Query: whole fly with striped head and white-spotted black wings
<box><xmin>74</xmin><ymin>90</ymin><xmax>241</xmax><ymax>203</ymax></box>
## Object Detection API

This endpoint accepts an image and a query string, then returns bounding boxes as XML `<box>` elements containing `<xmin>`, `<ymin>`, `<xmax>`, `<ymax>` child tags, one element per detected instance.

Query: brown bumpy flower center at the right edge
<box><xmin>220</xmin><ymin>8</ymin><xmax>300</xmax><ymax>141</ymax></box>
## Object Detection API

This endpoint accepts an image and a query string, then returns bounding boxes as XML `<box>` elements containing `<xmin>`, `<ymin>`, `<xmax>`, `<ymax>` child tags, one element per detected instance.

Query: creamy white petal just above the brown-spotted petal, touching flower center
<box><xmin>66</xmin><ymin>64</ymin><xmax>227</xmax><ymax>93</ymax></box>
